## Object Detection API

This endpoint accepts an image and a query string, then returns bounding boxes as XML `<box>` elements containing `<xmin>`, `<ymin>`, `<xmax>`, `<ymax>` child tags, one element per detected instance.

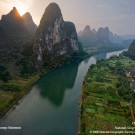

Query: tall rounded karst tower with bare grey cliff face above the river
<box><xmin>34</xmin><ymin>3</ymin><xmax>80</xmax><ymax>67</ymax></box>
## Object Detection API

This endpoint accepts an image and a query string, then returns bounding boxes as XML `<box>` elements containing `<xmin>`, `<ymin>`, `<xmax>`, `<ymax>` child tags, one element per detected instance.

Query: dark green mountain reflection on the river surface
<box><xmin>36</xmin><ymin>64</ymin><xmax>78</xmax><ymax>106</ymax></box>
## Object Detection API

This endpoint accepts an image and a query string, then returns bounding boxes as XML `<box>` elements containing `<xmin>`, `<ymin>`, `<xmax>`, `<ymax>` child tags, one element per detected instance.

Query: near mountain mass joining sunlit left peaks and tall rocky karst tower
<box><xmin>0</xmin><ymin>3</ymin><xmax>82</xmax><ymax>81</ymax></box>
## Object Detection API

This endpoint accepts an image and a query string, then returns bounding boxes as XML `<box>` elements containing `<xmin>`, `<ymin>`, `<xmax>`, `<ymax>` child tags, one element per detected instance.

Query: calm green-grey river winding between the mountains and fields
<box><xmin>0</xmin><ymin>51</ymin><xmax>126</xmax><ymax>135</ymax></box>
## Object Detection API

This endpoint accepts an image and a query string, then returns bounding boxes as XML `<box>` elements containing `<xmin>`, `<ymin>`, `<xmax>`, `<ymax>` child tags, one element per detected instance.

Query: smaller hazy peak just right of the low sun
<box><xmin>22</xmin><ymin>12</ymin><xmax>37</xmax><ymax>34</ymax></box>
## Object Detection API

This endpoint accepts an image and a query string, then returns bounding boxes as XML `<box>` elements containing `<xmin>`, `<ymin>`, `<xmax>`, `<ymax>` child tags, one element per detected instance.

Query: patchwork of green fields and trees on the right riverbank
<box><xmin>78</xmin><ymin>56</ymin><xmax>135</xmax><ymax>135</ymax></box>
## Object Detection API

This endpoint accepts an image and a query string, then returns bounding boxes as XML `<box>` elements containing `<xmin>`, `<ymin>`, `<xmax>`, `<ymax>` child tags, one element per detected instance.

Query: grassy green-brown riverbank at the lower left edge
<box><xmin>0</xmin><ymin>74</ymin><xmax>40</xmax><ymax>118</ymax></box>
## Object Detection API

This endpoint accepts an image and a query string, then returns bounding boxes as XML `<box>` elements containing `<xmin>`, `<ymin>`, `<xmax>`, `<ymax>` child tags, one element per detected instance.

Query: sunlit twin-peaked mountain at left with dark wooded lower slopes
<box><xmin>0</xmin><ymin>7</ymin><xmax>37</xmax><ymax>78</ymax></box>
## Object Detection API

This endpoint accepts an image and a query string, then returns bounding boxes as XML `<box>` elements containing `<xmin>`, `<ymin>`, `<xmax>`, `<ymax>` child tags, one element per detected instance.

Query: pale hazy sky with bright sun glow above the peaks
<box><xmin>0</xmin><ymin>0</ymin><xmax>135</xmax><ymax>35</ymax></box>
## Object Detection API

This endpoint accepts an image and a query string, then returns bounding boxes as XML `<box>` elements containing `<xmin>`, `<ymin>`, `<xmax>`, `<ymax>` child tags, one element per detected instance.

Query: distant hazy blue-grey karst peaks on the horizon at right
<box><xmin>78</xmin><ymin>25</ymin><xmax>133</xmax><ymax>50</ymax></box>
